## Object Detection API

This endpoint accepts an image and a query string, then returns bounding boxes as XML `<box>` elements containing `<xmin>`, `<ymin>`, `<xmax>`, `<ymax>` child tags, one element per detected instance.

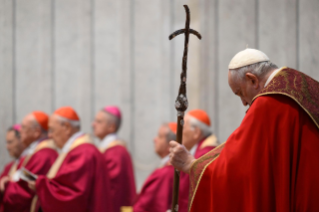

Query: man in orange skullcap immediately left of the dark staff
<box><xmin>133</xmin><ymin>122</ymin><xmax>177</xmax><ymax>212</ymax></box>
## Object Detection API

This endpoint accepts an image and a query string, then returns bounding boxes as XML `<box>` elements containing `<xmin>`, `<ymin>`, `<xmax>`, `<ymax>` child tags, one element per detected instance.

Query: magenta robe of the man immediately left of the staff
<box><xmin>133</xmin><ymin>164</ymin><xmax>174</xmax><ymax>212</ymax></box>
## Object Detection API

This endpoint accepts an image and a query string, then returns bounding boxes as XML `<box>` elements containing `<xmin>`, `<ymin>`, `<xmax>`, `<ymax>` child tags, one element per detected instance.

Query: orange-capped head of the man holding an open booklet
<box><xmin>49</xmin><ymin>107</ymin><xmax>81</xmax><ymax>149</ymax></box>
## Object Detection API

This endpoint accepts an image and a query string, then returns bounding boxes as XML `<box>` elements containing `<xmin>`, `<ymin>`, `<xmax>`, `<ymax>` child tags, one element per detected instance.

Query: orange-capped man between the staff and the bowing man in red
<box><xmin>178</xmin><ymin>109</ymin><xmax>218</xmax><ymax>212</ymax></box>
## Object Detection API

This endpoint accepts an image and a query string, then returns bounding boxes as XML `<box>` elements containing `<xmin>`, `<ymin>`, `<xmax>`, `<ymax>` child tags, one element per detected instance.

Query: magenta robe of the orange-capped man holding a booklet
<box><xmin>36</xmin><ymin>143</ymin><xmax>113</xmax><ymax>212</ymax></box>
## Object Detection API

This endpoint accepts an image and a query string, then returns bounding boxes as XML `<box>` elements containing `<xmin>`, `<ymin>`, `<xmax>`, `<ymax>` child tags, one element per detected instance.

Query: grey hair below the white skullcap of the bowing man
<box><xmin>229</xmin><ymin>61</ymin><xmax>278</xmax><ymax>79</ymax></box>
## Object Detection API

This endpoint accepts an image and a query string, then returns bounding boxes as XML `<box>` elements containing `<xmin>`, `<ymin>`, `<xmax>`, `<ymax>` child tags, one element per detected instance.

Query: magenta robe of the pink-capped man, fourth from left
<box><xmin>102</xmin><ymin>145</ymin><xmax>136</xmax><ymax>212</ymax></box>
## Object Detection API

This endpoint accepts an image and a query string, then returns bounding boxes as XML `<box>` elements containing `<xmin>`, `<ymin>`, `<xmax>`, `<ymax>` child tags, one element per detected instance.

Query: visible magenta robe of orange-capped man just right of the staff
<box><xmin>178</xmin><ymin>135</ymin><xmax>217</xmax><ymax>212</ymax></box>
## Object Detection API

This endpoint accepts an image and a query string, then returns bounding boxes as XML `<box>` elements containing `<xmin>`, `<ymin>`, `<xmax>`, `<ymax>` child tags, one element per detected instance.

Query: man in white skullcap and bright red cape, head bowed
<box><xmin>170</xmin><ymin>49</ymin><xmax>319</xmax><ymax>212</ymax></box>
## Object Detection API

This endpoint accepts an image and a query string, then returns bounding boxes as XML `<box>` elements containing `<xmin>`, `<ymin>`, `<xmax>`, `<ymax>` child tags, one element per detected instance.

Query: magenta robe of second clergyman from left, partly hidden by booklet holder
<box><xmin>3</xmin><ymin>140</ymin><xmax>58</xmax><ymax>212</ymax></box>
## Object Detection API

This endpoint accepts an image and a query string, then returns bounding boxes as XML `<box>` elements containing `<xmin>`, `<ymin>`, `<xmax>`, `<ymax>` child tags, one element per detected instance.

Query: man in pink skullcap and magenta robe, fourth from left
<box><xmin>92</xmin><ymin>106</ymin><xmax>136</xmax><ymax>212</ymax></box>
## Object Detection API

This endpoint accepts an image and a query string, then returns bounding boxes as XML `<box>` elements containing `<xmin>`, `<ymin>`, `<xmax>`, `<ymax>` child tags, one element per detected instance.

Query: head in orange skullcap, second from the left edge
<box><xmin>21</xmin><ymin>111</ymin><xmax>49</xmax><ymax>147</ymax></box>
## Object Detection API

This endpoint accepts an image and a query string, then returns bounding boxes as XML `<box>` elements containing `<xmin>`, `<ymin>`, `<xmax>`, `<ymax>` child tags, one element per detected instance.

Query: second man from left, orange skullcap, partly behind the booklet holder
<box><xmin>3</xmin><ymin>111</ymin><xmax>58</xmax><ymax>212</ymax></box>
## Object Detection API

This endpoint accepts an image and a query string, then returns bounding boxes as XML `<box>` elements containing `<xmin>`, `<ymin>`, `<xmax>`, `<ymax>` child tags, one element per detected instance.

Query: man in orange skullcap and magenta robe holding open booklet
<box><xmin>29</xmin><ymin>107</ymin><xmax>113</xmax><ymax>212</ymax></box>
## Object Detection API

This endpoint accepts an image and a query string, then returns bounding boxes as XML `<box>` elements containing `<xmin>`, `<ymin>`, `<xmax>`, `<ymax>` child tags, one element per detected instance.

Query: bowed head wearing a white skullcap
<box><xmin>228</xmin><ymin>49</ymin><xmax>278</xmax><ymax>106</ymax></box>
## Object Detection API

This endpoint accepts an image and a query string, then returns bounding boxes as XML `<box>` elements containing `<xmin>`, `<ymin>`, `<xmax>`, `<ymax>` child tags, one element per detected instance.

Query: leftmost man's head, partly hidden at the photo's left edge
<box><xmin>6</xmin><ymin>124</ymin><xmax>25</xmax><ymax>159</ymax></box>
